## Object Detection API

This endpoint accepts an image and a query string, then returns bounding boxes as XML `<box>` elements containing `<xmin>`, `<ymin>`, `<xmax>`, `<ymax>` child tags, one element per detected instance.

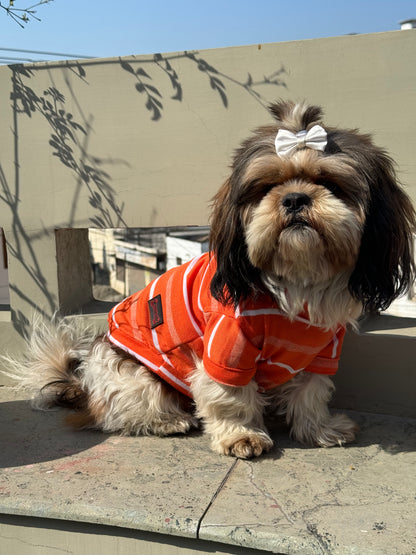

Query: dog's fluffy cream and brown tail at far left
<box><xmin>2</xmin><ymin>317</ymin><xmax>96</xmax><ymax>410</ymax></box>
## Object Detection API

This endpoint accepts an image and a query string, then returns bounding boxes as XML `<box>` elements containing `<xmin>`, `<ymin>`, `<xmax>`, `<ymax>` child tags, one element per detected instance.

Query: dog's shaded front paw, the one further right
<box><xmin>294</xmin><ymin>414</ymin><xmax>358</xmax><ymax>447</ymax></box>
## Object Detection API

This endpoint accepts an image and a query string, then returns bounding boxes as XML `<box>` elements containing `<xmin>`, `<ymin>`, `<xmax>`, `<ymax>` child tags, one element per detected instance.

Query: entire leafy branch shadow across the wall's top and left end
<box><xmin>0</xmin><ymin>52</ymin><xmax>286</xmax><ymax>335</ymax></box>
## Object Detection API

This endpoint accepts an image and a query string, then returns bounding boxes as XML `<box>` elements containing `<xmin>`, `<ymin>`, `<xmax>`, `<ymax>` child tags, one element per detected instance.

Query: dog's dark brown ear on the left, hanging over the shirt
<box><xmin>210</xmin><ymin>177</ymin><xmax>260</xmax><ymax>306</ymax></box>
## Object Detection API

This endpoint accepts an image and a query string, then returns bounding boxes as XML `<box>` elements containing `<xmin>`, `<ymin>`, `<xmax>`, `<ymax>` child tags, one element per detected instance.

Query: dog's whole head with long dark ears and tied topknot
<box><xmin>211</xmin><ymin>102</ymin><xmax>415</xmax><ymax>324</ymax></box>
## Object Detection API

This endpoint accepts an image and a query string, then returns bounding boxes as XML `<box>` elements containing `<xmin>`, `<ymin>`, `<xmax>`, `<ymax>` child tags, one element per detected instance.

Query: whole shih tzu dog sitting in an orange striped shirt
<box><xmin>4</xmin><ymin>102</ymin><xmax>416</xmax><ymax>458</ymax></box>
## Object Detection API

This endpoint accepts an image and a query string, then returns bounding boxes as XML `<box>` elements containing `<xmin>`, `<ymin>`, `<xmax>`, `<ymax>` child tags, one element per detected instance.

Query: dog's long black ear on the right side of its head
<box><xmin>349</xmin><ymin>149</ymin><xmax>416</xmax><ymax>312</ymax></box>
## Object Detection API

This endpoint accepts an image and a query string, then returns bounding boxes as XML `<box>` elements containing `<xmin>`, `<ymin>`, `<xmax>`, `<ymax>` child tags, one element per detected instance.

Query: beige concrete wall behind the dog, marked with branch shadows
<box><xmin>0</xmin><ymin>30</ymin><xmax>416</xmax><ymax>412</ymax></box>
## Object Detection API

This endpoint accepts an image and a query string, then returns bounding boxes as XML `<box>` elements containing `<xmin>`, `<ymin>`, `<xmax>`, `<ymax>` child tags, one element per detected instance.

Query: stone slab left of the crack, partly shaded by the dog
<box><xmin>0</xmin><ymin>388</ymin><xmax>234</xmax><ymax>537</ymax></box>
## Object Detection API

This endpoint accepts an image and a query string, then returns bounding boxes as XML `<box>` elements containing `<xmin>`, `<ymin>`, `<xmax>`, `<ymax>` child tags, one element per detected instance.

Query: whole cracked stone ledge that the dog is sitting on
<box><xmin>0</xmin><ymin>387</ymin><xmax>416</xmax><ymax>555</ymax></box>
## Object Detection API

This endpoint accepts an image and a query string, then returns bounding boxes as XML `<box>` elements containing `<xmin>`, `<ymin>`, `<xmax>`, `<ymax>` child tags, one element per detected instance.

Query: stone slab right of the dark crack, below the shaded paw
<box><xmin>199</xmin><ymin>413</ymin><xmax>416</xmax><ymax>555</ymax></box>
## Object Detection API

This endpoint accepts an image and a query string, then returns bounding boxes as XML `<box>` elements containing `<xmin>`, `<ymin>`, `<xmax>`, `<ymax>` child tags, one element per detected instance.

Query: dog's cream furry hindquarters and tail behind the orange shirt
<box><xmin>3</xmin><ymin>317</ymin><xmax>198</xmax><ymax>436</ymax></box>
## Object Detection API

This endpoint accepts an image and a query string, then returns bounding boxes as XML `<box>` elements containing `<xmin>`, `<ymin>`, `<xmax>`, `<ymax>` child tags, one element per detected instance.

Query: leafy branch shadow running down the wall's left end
<box><xmin>0</xmin><ymin>65</ymin><xmax>127</xmax><ymax>336</ymax></box>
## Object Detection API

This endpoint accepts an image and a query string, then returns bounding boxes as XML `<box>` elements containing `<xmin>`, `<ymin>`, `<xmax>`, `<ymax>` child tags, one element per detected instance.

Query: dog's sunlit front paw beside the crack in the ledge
<box><xmin>212</xmin><ymin>432</ymin><xmax>273</xmax><ymax>459</ymax></box>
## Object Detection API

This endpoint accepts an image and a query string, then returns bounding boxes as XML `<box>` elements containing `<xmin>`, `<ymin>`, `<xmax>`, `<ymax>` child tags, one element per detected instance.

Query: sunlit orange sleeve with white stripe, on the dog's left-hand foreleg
<box><xmin>203</xmin><ymin>314</ymin><xmax>261</xmax><ymax>387</ymax></box>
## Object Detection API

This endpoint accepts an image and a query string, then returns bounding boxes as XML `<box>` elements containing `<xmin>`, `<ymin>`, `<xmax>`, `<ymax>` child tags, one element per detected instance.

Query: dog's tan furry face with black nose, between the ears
<box><xmin>241</xmin><ymin>149</ymin><xmax>368</xmax><ymax>285</ymax></box>
